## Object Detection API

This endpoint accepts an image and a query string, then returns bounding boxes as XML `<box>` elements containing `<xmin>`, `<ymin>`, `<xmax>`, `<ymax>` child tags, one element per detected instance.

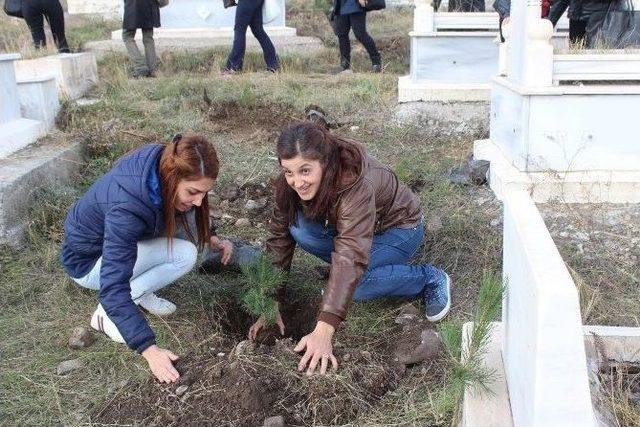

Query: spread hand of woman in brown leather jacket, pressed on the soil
<box><xmin>293</xmin><ymin>322</ymin><xmax>338</xmax><ymax>375</ymax></box>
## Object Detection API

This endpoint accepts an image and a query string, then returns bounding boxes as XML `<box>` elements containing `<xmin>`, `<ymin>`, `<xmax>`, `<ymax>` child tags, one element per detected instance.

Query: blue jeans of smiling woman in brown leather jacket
<box><xmin>289</xmin><ymin>213</ymin><xmax>444</xmax><ymax>301</ymax></box>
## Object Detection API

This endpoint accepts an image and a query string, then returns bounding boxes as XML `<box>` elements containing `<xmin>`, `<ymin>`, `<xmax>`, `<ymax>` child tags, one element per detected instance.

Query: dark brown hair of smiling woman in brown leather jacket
<box><xmin>276</xmin><ymin>121</ymin><xmax>362</xmax><ymax>224</ymax></box>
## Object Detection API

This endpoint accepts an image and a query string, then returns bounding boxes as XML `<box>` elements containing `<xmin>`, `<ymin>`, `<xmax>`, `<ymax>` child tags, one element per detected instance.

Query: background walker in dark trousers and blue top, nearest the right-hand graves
<box><xmin>333</xmin><ymin>0</ymin><xmax>382</xmax><ymax>73</ymax></box>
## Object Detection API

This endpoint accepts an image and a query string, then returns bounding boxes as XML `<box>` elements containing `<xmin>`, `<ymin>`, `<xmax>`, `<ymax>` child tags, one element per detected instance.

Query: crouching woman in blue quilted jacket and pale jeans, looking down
<box><xmin>61</xmin><ymin>134</ymin><xmax>233</xmax><ymax>382</ymax></box>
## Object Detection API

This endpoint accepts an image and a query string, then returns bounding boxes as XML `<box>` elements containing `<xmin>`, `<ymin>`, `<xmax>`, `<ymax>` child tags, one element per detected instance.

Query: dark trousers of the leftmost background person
<box><xmin>22</xmin><ymin>0</ymin><xmax>69</xmax><ymax>53</ymax></box>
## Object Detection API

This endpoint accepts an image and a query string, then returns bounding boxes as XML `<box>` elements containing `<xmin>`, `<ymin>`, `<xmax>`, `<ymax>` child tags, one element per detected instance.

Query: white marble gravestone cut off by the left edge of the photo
<box><xmin>0</xmin><ymin>53</ymin><xmax>45</xmax><ymax>158</ymax></box>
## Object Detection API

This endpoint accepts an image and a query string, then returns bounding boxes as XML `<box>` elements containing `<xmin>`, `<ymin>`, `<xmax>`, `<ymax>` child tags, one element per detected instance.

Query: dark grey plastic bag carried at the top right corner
<box><xmin>585</xmin><ymin>0</ymin><xmax>640</xmax><ymax>49</ymax></box>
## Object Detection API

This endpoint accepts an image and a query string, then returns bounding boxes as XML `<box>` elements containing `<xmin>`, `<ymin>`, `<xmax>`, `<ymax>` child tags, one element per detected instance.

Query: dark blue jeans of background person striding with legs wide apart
<box><xmin>225</xmin><ymin>0</ymin><xmax>279</xmax><ymax>71</ymax></box>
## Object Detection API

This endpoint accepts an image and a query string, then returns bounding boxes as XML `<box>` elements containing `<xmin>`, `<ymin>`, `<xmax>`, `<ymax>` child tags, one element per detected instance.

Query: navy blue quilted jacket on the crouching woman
<box><xmin>61</xmin><ymin>144</ymin><xmax>164</xmax><ymax>353</ymax></box>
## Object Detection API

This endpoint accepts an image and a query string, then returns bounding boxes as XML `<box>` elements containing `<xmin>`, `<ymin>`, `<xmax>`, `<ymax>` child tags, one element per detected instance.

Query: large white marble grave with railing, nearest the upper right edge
<box><xmin>475</xmin><ymin>0</ymin><xmax>640</xmax><ymax>203</ymax></box>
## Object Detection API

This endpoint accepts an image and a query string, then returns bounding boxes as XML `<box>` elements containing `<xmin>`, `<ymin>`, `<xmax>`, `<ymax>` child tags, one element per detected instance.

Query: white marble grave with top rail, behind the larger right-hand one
<box><xmin>398</xmin><ymin>0</ymin><xmax>568</xmax><ymax>102</ymax></box>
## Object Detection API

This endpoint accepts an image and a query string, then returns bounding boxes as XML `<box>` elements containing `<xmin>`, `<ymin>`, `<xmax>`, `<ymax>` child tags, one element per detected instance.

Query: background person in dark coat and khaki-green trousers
<box><xmin>122</xmin><ymin>0</ymin><xmax>160</xmax><ymax>77</ymax></box>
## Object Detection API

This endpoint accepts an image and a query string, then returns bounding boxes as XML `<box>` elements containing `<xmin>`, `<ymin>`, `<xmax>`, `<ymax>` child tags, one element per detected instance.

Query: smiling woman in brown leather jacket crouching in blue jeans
<box><xmin>249</xmin><ymin>122</ymin><xmax>451</xmax><ymax>375</ymax></box>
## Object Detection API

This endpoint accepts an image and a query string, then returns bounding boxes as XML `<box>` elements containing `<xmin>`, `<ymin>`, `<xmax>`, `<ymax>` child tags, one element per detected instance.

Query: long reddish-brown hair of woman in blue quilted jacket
<box><xmin>160</xmin><ymin>133</ymin><xmax>219</xmax><ymax>249</ymax></box>
